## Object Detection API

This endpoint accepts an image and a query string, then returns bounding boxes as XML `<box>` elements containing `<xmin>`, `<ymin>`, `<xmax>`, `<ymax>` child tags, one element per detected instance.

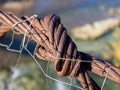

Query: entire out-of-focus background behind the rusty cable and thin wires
<box><xmin>0</xmin><ymin>0</ymin><xmax>120</xmax><ymax>90</ymax></box>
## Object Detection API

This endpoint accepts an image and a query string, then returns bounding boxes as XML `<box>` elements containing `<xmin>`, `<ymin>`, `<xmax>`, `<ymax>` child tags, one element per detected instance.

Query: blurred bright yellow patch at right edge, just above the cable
<box><xmin>102</xmin><ymin>27</ymin><xmax>120</xmax><ymax>67</ymax></box>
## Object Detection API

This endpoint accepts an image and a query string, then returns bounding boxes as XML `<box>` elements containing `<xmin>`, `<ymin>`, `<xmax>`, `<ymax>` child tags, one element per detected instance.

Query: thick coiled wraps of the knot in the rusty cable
<box><xmin>37</xmin><ymin>15</ymin><xmax>80</xmax><ymax>77</ymax></box>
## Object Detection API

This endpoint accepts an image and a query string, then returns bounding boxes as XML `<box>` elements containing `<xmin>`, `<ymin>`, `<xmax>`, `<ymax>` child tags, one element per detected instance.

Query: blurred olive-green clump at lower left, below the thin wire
<box><xmin>11</xmin><ymin>63</ymin><xmax>48</xmax><ymax>90</ymax></box>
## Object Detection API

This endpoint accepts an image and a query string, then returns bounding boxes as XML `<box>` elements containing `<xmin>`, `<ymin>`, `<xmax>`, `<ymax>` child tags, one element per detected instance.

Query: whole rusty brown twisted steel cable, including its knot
<box><xmin>0</xmin><ymin>11</ymin><xmax>120</xmax><ymax>90</ymax></box>
